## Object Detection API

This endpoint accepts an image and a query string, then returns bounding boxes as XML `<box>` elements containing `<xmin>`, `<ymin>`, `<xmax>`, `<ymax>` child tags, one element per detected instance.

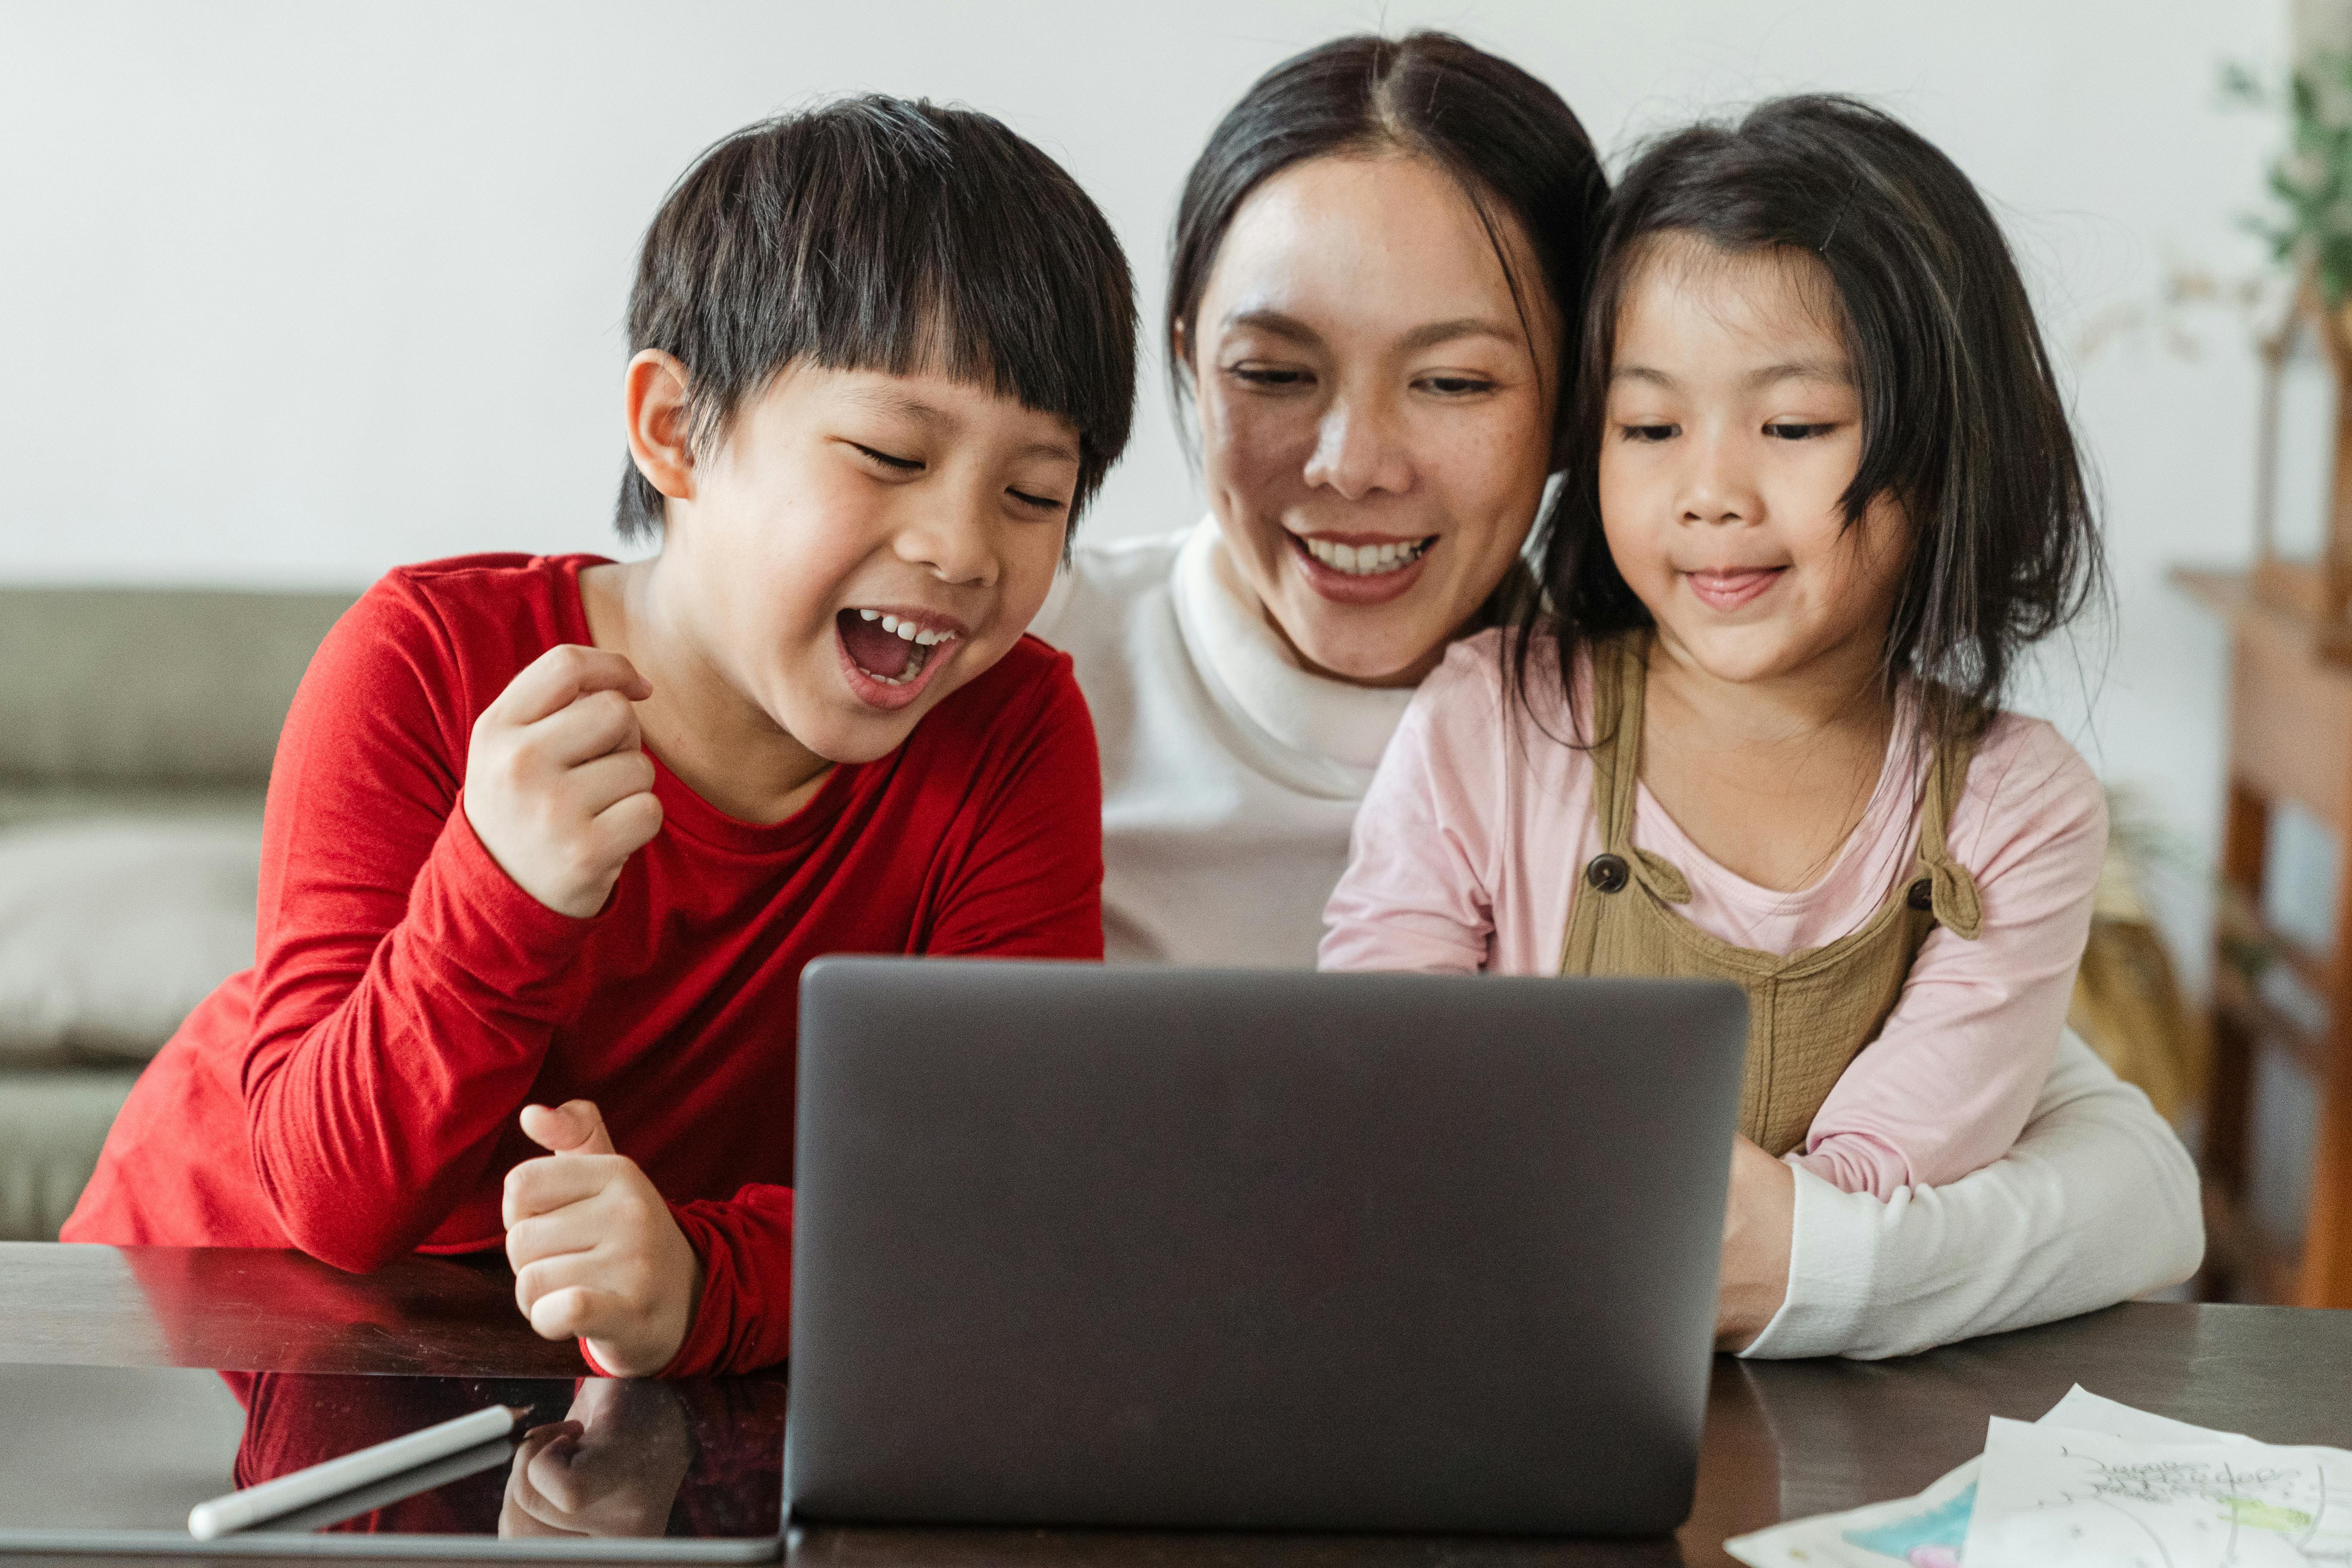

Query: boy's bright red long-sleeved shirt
<box><xmin>66</xmin><ymin>555</ymin><xmax>1103</xmax><ymax>1375</ymax></box>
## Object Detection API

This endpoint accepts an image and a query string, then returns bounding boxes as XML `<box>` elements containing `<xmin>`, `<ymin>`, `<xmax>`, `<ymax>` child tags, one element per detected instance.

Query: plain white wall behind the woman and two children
<box><xmin>0</xmin><ymin>0</ymin><xmax>2289</xmax><ymax>982</ymax></box>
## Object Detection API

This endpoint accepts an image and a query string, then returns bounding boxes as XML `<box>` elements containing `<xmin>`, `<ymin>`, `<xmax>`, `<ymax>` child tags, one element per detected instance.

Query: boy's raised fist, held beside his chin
<box><xmin>466</xmin><ymin>642</ymin><xmax>661</xmax><ymax>919</ymax></box>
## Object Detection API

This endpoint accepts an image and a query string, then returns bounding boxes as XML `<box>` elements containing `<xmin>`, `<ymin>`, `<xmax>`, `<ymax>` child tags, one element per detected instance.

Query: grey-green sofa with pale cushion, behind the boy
<box><xmin>0</xmin><ymin>588</ymin><xmax>355</xmax><ymax>1241</ymax></box>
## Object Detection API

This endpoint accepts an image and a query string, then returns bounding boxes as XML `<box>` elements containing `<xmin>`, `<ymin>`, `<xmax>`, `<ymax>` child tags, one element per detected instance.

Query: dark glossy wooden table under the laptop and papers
<box><xmin>0</xmin><ymin>1244</ymin><xmax>2352</xmax><ymax>1568</ymax></box>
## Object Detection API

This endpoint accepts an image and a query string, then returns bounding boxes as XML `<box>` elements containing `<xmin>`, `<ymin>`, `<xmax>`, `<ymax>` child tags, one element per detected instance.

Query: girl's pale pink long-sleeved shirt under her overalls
<box><xmin>1319</xmin><ymin>633</ymin><xmax>2107</xmax><ymax>1196</ymax></box>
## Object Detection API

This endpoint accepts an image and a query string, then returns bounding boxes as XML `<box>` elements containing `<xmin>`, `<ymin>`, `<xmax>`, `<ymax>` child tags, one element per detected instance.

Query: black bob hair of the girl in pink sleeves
<box><xmin>1514</xmin><ymin>96</ymin><xmax>2105</xmax><ymax>738</ymax></box>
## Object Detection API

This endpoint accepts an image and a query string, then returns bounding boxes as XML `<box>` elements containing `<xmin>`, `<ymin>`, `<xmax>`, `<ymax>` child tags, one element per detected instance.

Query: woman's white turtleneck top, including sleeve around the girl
<box><xmin>1033</xmin><ymin>520</ymin><xmax>2204</xmax><ymax>1357</ymax></box>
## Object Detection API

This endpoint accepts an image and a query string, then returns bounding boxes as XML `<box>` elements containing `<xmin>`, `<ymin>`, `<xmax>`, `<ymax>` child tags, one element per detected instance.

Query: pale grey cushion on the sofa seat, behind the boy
<box><xmin>0</xmin><ymin>818</ymin><xmax>261</xmax><ymax>1063</ymax></box>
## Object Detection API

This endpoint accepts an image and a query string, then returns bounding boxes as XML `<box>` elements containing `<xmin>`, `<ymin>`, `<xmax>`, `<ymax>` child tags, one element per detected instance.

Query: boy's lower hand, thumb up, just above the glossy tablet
<box><xmin>506</xmin><ymin>1100</ymin><xmax>703</xmax><ymax>1378</ymax></box>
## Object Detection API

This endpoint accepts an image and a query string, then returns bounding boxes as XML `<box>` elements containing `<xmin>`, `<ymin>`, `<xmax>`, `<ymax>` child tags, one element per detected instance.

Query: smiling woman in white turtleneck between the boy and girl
<box><xmin>1037</xmin><ymin>33</ymin><xmax>2204</xmax><ymax>1357</ymax></box>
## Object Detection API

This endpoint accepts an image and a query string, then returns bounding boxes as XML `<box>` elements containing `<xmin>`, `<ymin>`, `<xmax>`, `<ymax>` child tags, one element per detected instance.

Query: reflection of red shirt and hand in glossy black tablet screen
<box><xmin>224</xmin><ymin>1373</ymin><xmax>783</xmax><ymax>1537</ymax></box>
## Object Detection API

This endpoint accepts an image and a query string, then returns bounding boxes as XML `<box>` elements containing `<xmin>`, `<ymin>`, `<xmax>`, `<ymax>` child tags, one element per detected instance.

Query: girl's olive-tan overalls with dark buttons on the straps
<box><xmin>1559</xmin><ymin>635</ymin><xmax>1983</xmax><ymax>1157</ymax></box>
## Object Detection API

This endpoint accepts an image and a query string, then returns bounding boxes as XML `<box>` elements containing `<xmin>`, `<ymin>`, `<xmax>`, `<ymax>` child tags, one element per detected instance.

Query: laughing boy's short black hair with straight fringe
<box><xmin>614</xmin><ymin>94</ymin><xmax>1136</xmax><ymax>541</ymax></box>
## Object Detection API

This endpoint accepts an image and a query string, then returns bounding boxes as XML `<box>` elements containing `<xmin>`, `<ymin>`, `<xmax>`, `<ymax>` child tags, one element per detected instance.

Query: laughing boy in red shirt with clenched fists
<box><xmin>66</xmin><ymin>96</ymin><xmax>1133</xmax><ymax>1375</ymax></box>
